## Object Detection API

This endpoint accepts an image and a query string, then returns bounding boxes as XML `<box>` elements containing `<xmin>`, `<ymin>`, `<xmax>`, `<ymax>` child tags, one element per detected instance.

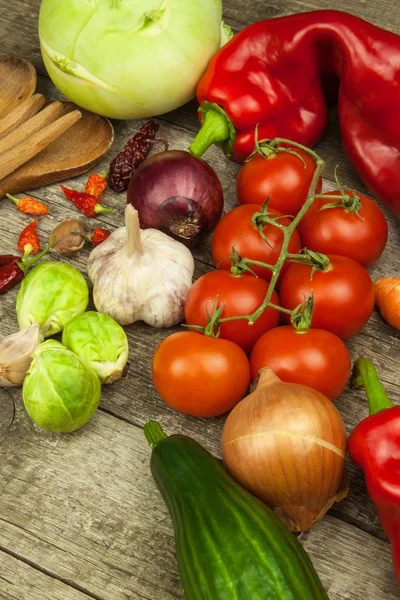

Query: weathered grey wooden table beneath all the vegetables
<box><xmin>0</xmin><ymin>0</ymin><xmax>400</xmax><ymax>600</ymax></box>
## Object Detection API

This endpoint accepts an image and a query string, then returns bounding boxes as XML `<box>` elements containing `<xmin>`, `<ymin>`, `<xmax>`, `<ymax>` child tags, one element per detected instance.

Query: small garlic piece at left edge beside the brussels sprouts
<box><xmin>0</xmin><ymin>323</ymin><xmax>41</xmax><ymax>387</ymax></box>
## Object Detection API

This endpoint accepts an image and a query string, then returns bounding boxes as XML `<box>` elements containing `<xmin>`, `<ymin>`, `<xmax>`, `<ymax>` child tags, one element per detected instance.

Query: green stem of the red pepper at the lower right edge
<box><xmin>351</xmin><ymin>358</ymin><xmax>393</xmax><ymax>416</ymax></box>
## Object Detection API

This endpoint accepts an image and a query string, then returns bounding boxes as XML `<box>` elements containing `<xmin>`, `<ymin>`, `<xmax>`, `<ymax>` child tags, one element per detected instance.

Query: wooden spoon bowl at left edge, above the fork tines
<box><xmin>0</xmin><ymin>54</ymin><xmax>37</xmax><ymax>118</ymax></box>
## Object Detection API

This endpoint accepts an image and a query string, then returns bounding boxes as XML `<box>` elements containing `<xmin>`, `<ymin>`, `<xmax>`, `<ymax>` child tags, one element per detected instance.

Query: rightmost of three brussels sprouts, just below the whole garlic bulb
<box><xmin>62</xmin><ymin>311</ymin><xmax>129</xmax><ymax>383</ymax></box>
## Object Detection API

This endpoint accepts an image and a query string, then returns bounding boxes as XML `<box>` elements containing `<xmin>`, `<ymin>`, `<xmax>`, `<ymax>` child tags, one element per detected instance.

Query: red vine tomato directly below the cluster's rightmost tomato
<box><xmin>279</xmin><ymin>255</ymin><xmax>375</xmax><ymax>340</ymax></box>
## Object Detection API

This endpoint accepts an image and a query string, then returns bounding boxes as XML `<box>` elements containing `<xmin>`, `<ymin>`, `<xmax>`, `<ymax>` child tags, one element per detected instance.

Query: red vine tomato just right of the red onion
<box><xmin>211</xmin><ymin>204</ymin><xmax>301</xmax><ymax>281</ymax></box>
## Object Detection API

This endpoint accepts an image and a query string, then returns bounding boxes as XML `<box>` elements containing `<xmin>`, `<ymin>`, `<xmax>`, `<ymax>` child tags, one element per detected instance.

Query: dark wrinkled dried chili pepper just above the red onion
<box><xmin>108</xmin><ymin>121</ymin><xmax>160</xmax><ymax>192</ymax></box>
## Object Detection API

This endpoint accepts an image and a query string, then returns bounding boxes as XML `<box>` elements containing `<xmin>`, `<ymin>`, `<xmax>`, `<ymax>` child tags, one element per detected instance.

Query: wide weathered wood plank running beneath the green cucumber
<box><xmin>0</xmin><ymin>404</ymin><xmax>398</xmax><ymax>600</ymax></box>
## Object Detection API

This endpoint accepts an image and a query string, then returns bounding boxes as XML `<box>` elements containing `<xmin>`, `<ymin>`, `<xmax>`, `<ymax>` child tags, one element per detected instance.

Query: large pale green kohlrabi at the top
<box><xmin>39</xmin><ymin>0</ymin><xmax>230</xmax><ymax>119</ymax></box>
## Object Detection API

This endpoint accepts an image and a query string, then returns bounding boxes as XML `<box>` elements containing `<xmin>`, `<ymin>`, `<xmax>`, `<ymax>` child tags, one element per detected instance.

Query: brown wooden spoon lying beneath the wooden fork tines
<box><xmin>0</xmin><ymin>102</ymin><xmax>114</xmax><ymax>198</ymax></box>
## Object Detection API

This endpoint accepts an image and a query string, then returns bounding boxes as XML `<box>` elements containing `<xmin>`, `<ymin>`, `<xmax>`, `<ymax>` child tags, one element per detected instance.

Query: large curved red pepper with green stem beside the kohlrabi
<box><xmin>190</xmin><ymin>10</ymin><xmax>400</xmax><ymax>217</ymax></box>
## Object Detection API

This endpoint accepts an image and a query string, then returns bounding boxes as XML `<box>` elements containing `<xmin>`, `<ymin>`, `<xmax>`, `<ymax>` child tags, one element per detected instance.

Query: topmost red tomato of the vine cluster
<box><xmin>236</xmin><ymin>149</ymin><xmax>322</xmax><ymax>216</ymax></box>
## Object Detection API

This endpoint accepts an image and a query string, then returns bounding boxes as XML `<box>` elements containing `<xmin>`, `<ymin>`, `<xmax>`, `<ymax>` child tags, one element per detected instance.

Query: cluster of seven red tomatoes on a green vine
<box><xmin>153</xmin><ymin>149</ymin><xmax>388</xmax><ymax>417</ymax></box>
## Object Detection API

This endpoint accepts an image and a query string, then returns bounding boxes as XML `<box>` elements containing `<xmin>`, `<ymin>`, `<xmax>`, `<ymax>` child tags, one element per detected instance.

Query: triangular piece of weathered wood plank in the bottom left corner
<box><xmin>0</xmin><ymin>550</ymin><xmax>91</xmax><ymax>600</ymax></box>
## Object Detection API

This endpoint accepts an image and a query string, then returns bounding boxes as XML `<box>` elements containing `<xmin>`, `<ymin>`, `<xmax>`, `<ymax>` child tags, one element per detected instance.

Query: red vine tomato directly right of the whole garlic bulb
<box><xmin>185</xmin><ymin>271</ymin><xmax>280</xmax><ymax>352</ymax></box>
